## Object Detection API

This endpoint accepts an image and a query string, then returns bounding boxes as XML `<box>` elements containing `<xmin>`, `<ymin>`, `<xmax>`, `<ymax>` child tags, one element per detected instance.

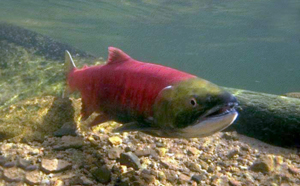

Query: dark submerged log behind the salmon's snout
<box><xmin>225</xmin><ymin>88</ymin><xmax>300</xmax><ymax>148</ymax></box>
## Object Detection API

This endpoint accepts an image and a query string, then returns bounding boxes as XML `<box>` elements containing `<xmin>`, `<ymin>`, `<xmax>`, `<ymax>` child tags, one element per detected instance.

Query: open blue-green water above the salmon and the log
<box><xmin>0</xmin><ymin>0</ymin><xmax>300</xmax><ymax>94</ymax></box>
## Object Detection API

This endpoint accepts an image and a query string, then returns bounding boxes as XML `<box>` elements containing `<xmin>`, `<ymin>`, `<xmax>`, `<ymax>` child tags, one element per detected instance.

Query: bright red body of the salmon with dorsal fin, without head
<box><xmin>68</xmin><ymin>47</ymin><xmax>196</xmax><ymax>124</ymax></box>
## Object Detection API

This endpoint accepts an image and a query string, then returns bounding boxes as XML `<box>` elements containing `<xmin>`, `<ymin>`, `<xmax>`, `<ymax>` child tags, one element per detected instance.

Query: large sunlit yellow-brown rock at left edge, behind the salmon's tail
<box><xmin>0</xmin><ymin>96</ymin><xmax>75</xmax><ymax>142</ymax></box>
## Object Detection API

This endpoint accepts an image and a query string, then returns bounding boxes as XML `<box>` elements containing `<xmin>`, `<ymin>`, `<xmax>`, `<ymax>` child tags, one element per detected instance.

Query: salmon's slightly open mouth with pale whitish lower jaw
<box><xmin>181</xmin><ymin>102</ymin><xmax>238</xmax><ymax>138</ymax></box>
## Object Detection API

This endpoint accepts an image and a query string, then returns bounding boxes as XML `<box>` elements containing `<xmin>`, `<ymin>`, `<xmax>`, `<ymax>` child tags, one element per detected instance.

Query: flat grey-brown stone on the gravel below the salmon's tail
<box><xmin>53</xmin><ymin>136</ymin><xmax>84</xmax><ymax>150</ymax></box>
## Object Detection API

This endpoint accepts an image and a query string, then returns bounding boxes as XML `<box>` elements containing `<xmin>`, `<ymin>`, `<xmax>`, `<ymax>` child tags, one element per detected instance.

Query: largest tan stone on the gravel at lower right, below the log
<box><xmin>250</xmin><ymin>156</ymin><xmax>274</xmax><ymax>173</ymax></box>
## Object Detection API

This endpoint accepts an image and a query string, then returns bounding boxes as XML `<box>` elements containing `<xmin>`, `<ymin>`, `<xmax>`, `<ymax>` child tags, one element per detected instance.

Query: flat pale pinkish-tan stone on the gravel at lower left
<box><xmin>41</xmin><ymin>159</ymin><xmax>72</xmax><ymax>174</ymax></box>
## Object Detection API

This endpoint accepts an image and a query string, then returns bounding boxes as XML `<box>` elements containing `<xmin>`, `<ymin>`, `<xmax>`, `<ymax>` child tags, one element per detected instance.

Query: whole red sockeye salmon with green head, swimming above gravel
<box><xmin>65</xmin><ymin>47</ymin><xmax>238</xmax><ymax>138</ymax></box>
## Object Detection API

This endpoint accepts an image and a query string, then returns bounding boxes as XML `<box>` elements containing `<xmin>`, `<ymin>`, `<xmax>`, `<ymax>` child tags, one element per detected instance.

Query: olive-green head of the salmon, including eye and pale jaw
<box><xmin>152</xmin><ymin>78</ymin><xmax>238</xmax><ymax>138</ymax></box>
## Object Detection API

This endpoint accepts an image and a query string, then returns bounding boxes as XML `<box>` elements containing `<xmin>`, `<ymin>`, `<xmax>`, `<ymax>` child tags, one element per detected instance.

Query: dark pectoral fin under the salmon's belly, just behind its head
<box><xmin>113</xmin><ymin>122</ymin><xmax>153</xmax><ymax>133</ymax></box>
